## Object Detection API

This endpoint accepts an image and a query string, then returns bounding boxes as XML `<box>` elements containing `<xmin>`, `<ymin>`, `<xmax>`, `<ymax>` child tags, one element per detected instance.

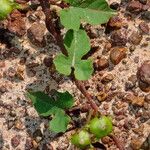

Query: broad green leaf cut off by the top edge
<box><xmin>60</xmin><ymin>0</ymin><xmax>115</xmax><ymax>30</ymax></box>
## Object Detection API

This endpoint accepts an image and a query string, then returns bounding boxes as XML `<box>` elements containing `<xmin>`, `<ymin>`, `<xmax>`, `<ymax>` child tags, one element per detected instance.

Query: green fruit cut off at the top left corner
<box><xmin>0</xmin><ymin>0</ymin><xmax>17</xmax><ymax>20</ymax></box>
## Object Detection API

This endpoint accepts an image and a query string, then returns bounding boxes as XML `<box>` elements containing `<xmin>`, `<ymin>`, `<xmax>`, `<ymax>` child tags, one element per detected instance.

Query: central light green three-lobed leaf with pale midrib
<box><xmin>54</xmin><ymin>29</ymin><xmax>93</xmax><ymax>80</ymax></box>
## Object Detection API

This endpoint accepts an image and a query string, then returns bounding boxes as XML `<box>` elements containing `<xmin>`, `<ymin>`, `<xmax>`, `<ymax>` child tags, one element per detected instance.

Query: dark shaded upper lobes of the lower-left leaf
<box><xmin>27</xmin><ymin>91</ymin><xmax>74</xmax><ymax>116</ymax></box>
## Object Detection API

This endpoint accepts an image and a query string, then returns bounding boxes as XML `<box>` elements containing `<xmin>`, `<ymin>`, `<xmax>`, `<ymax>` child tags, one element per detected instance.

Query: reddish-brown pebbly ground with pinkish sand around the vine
<box><xmin>0</xmin><ymin>0</ymin><xmax>150</xmax><ymax>150</ymax></box>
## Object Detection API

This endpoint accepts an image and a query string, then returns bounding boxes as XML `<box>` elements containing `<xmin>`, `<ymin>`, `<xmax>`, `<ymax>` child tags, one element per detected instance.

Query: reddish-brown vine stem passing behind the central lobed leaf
<box><xmin>40</xmin><ymin>0</ymin><xmax>98</xmax><ymax>115</ymax></box>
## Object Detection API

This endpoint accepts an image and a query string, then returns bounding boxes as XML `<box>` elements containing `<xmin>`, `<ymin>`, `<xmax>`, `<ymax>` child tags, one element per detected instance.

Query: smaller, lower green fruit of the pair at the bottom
<box><xmin>71</xmin><ymin>130</ymin><xmax>91</xmax><ymax>149</ymax></box>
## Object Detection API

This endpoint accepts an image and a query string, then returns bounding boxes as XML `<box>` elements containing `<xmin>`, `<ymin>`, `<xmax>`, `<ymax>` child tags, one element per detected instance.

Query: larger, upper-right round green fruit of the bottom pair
<box><xmin>89</xmin><ymin>116</ymin><xmax>113</xmax><ymax>139</ymax></box>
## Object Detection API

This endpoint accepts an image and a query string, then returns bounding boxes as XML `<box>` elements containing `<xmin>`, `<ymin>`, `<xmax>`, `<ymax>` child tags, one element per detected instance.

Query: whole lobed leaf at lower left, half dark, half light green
<box><xmin>27</xmin><ymin>91</ymin><xmax>74</xmax><ymax>133</ymax></box>
